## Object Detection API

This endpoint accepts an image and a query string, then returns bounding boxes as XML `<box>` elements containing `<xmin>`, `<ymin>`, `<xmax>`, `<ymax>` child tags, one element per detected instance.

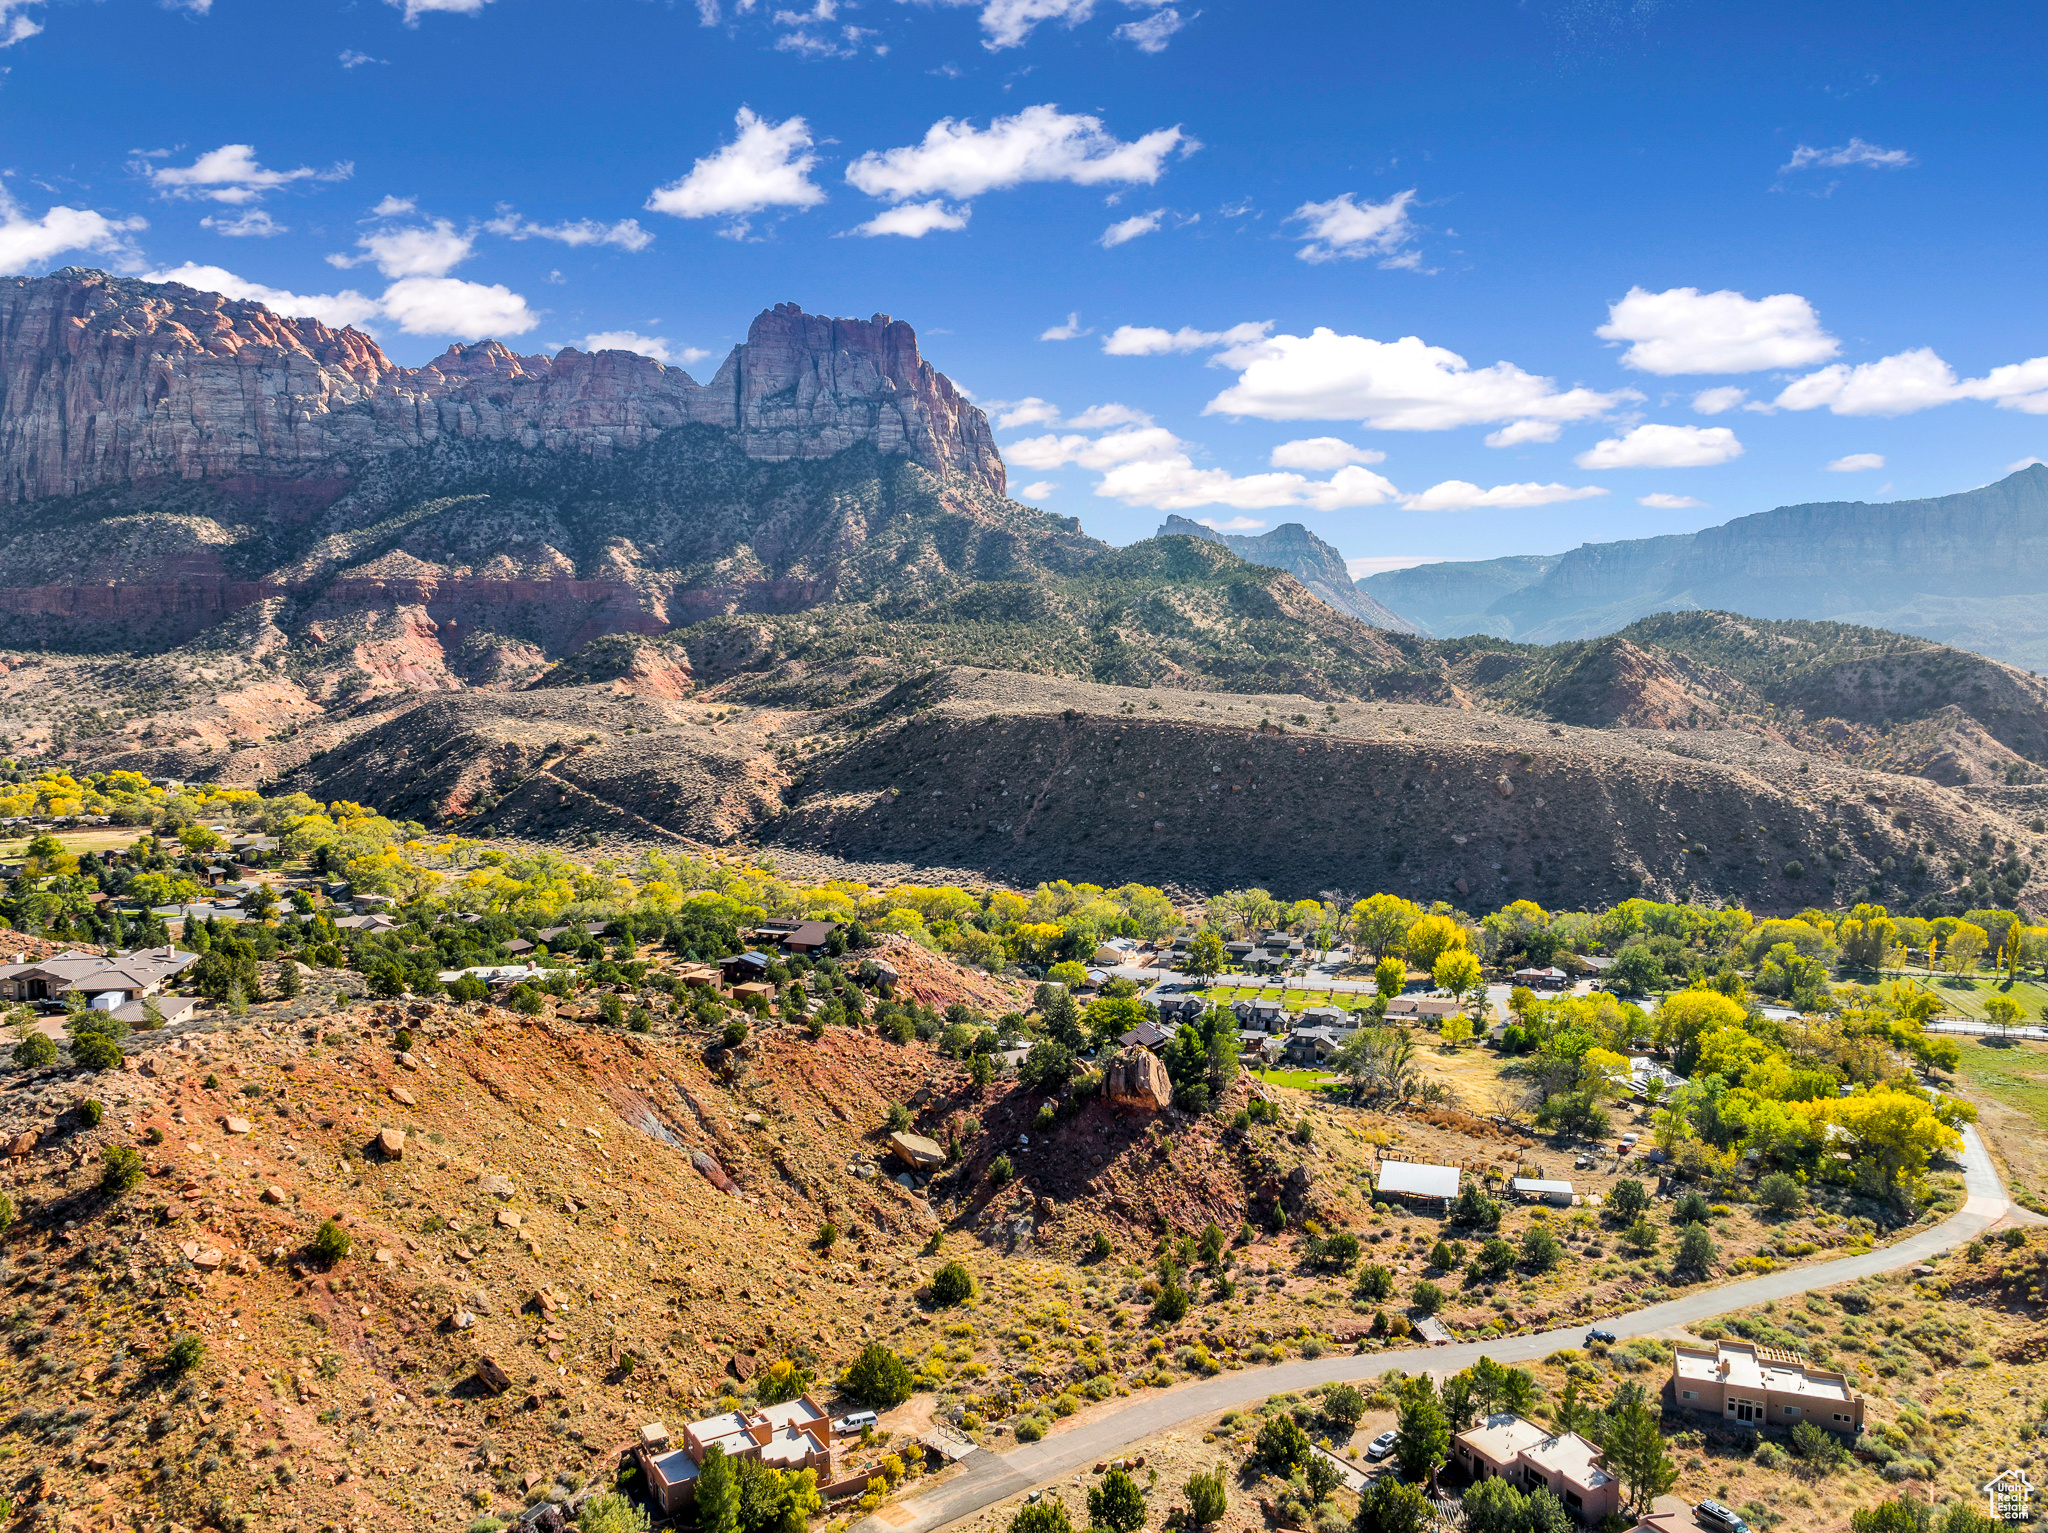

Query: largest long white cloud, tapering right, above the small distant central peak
<box><xmin>1204</xmin><ymin>325</ymin><xmax>1642</xmax><ymax>432</ymax></box>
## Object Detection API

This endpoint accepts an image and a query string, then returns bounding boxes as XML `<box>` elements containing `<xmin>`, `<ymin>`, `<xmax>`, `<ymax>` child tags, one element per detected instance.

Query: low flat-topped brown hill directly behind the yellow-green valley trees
<box><xmin>260</xmin><ymin>663</ymin><xmax>2048</xmax><ymax>913</ymax></box>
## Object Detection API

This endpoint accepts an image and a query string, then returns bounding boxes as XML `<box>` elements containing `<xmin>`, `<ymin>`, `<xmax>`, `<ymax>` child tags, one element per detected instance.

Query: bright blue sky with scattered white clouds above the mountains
<box><xmin>0</xmin><ymin>0</ymin><xmax>2048</xmax><ymax>563</ymax></box>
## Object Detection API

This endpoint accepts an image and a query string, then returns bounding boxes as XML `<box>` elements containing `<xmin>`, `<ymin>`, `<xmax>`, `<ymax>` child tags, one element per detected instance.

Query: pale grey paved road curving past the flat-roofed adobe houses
<box><xmin>852</xmin><ymin>1128</ymin><xmax>2011</xmax><ymax>1533</ymax></box>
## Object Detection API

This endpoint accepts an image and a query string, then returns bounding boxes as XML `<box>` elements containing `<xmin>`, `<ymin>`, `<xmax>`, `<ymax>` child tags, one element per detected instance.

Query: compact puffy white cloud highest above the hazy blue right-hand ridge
<box><xmin>1593</xmin><ymin>287</ymin><xmax>1841</xmax><ymax>377</ymax></box>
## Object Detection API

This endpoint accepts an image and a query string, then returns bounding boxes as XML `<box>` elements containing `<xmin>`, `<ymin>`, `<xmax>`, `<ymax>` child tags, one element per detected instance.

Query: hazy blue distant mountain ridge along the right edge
<box><xmin>1358</xmin><ymin>463</ymin><xmax>2048</xmax><ymax>669</ymax></box>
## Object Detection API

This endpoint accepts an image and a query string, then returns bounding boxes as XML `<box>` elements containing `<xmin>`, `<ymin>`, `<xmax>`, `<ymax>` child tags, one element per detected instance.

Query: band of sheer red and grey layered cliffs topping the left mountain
<box><xmin>0</xmin><ymin>266</ymin><xmax>1004</xmax><ymax>501</ymax></box>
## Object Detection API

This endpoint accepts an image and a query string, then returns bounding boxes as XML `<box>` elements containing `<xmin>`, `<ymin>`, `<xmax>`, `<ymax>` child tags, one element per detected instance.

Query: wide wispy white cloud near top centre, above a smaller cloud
<box><xmin>843</xmin><ymin>104</ymin><xmax>1194</xmax><ymax>203</ymax></box>
